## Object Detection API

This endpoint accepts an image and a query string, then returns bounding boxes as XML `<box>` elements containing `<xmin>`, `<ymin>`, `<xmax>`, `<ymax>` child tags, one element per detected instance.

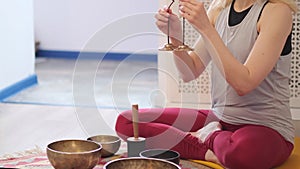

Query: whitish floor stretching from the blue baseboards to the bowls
<box><xmin>0</xmin><ymin>59</ymin><xmax>157</xmax><ymax>157</ymax></box>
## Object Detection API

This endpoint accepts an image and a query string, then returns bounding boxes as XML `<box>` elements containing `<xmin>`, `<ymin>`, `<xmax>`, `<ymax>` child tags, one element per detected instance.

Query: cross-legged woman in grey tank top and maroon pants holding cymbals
<box><xmin>116</xmin><ymin>0</ymin><xmax>297</xmax><ymax>169</ymax></box>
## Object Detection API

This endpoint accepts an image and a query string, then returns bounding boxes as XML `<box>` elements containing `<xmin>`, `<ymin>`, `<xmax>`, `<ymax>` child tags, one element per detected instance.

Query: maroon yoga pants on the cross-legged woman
<box><xmin>116</xmin><ymin>108</ymin><xmax>293</xmax><ymax>169</ymax></box>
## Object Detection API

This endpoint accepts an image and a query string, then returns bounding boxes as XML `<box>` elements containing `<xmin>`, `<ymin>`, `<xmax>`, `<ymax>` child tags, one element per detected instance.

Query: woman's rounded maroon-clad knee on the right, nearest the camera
<box><xmin>214</xmin><ymin>126</ymin><xmax>289</xmax><ymax>169</ymax></box>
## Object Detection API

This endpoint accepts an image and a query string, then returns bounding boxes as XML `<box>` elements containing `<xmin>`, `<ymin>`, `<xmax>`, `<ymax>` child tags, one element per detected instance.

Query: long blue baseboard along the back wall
<box><xmin>36</xmin><ymin>50</ymin><xmax>157</xmax><ymax>62</ymax></box>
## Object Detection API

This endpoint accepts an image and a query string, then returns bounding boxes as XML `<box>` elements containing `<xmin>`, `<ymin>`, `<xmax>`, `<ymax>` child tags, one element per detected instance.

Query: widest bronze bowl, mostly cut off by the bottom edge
<box><xmin>103</xmin><ymin>157</ymin><xmax>180</xmax><ymax>169</ymax></box>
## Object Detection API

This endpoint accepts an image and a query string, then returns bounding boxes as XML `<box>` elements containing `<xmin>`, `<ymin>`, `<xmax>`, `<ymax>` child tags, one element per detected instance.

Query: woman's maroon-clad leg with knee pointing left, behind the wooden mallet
<box><xmin>116</xmin><ymin>108</ymin><xmax>216</xmax><ymax>159</ymax></box>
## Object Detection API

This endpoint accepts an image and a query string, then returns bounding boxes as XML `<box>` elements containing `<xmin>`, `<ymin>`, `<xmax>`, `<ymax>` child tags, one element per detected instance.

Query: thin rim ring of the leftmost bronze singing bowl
<box><xmin>47</xmin><ymin>139</ymin><xmax>102</xmax><ymax>155</ymax></box>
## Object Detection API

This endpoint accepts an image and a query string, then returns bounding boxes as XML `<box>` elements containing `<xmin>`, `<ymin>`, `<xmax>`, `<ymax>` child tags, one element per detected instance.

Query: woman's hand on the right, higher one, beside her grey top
<box><xmin>179</xmin><ymin>0</ymin><xmax>212</xmax><ymax>33</ymax></box>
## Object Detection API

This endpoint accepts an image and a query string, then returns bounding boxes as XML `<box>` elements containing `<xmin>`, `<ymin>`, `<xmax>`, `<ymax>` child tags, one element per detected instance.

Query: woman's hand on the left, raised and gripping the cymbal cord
<box><xmin>155</xmin><ymin>7</ymin><xmax>182</xmax><ymax>41</ymax></box>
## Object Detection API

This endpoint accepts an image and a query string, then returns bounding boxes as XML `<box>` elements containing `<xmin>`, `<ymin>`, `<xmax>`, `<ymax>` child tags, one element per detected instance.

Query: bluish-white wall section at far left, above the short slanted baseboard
<box><xmin>0</xmin><ymin>0</ymin><xmax>35</xmax><ymax>91</ymax></box>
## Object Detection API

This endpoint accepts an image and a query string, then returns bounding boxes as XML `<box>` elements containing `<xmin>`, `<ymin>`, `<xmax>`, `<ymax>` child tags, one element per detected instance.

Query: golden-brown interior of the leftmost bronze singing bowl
<box><xmin>48</xmin><ymin>140</ymin><xmax>101</xmax><ymax>153</ymax></box>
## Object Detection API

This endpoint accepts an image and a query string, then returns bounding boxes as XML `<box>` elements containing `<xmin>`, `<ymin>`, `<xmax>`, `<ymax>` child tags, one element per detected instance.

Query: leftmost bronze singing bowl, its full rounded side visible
<box><xmin>47</xmin><ymin>140</ymin><xmax>102</xmax><ymax>169</ymax></box>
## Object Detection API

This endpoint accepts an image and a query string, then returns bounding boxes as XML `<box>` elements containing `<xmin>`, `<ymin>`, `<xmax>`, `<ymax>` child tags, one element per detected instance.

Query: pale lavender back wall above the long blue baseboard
<box><xmin>34</xmin><ymin>0</ymin><xmax>158</xmax><ymax>53</ymax></box>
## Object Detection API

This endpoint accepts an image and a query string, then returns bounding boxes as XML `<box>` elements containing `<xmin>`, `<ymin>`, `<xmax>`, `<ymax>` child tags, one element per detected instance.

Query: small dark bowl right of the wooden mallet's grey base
<box><xmin>140</xmin><ymin>149</ymin><xmax>180</xmax><ymax>164</ymax></box>
